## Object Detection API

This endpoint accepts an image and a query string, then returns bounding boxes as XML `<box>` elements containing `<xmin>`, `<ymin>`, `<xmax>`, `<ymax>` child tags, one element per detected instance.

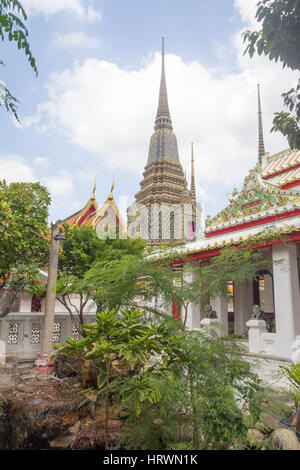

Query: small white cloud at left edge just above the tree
<box><xmin>0</xmin><ymin>155</ymin><xmax>37</xmax><ymax>183</ymax></box>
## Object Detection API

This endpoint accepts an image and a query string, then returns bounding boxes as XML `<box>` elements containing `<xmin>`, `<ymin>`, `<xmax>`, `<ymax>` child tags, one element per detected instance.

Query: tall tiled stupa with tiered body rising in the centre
<box><xmin>128</xmin><ymin>38</ymin><xmax>201</xmax><ymax>245</ymax></box>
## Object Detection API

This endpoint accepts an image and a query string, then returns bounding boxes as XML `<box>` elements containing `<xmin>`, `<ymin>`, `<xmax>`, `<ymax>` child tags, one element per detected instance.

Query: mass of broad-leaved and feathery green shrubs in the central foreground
<box><xmin>57</xmin><ymin>310</ymin><xmax>260</xmax><ymax>450</ymax></box>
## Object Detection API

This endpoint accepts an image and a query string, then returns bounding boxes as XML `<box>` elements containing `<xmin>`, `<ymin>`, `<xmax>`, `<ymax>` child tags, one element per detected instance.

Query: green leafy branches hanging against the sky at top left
<box><xmin>0</xmin><ymin>0</ymin><xmax>38</xmax><ymax>121</ymax></box>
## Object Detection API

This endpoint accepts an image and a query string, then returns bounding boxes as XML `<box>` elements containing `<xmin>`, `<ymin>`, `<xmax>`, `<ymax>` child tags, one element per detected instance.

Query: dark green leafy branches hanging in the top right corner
<box><xmin>244</xmin><ymin>0</ymin><xmax>300</xmax><ymax>149</ymax></box>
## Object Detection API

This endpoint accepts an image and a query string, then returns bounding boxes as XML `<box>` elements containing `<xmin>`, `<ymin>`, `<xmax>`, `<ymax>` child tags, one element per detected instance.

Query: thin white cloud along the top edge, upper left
<box><xmin>22</xmin><ymin>0</ymin><xmax>101</xmax><ymax>23</ymax></box>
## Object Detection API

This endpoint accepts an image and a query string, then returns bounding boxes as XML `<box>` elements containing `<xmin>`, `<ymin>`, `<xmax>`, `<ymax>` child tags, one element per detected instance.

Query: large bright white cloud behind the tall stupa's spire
<box><xmin>25</xmin><ymin>0</ymin><xmax>296</xmax><ymax>198</ymax></box>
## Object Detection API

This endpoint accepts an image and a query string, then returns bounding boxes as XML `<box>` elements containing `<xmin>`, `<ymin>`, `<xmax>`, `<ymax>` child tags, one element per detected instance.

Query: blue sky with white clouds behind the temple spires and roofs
<box><xmin>0</xmin><ymin>0</ymin><xmax>297</xmax><ymax>228</ymax></box>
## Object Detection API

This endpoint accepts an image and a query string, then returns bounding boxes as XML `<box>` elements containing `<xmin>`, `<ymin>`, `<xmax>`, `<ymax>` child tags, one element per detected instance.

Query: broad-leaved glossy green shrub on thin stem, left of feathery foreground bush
<box><xmin>52</xmin><ymin>310</ymin><xmax>161</xmax><ymax>450</ymax></box>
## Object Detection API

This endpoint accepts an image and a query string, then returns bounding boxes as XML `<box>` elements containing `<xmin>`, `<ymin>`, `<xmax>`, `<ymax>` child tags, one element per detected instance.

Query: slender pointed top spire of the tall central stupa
<box><xmin>154</xmin><ymin>37</ymin><xmax>173</xmax><ymax>130</ymax></box>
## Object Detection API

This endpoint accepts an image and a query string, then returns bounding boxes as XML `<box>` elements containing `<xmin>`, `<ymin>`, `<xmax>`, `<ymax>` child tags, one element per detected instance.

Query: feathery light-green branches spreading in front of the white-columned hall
<box><xmin>78</xmin><ymin>233</ymin><xmax>278</xmax><ymax>327</ymax></box>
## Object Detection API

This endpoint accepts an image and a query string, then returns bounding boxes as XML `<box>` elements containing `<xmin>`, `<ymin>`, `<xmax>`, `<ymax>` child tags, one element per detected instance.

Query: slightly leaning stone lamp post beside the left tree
<box><xmin>35</xmin><ymin>220</ymin><xmax>65</xmax><ymax>375</ymax></box>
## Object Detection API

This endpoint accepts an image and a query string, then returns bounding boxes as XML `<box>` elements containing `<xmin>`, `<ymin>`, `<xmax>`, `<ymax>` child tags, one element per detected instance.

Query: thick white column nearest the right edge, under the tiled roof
<box><xmin>272</xmin><ymin>244</ymin><xmax>300</xmax><ymax>358</ymax></box>
